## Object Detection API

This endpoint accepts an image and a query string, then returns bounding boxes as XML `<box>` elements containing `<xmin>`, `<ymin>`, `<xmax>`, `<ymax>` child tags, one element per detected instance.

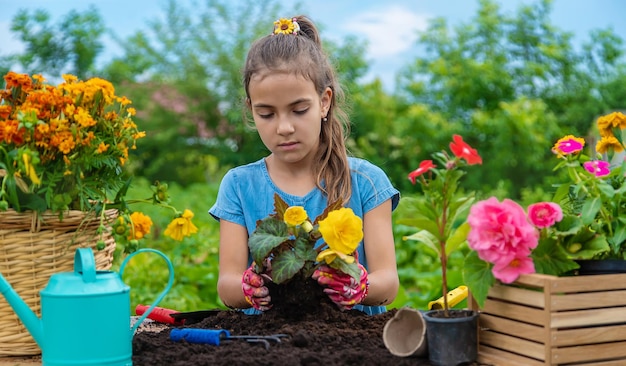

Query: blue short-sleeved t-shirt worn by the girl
<box><xmin>209</xmin><ymin>157</ymin><xmax>400</xmax><ymax>315</ymax></box>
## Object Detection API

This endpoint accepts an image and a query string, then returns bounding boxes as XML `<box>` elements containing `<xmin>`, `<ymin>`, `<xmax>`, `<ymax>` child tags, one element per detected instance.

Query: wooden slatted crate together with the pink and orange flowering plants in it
<box><xmin>464</xmin><ymin>112</ymin><xmax>626</xmax><ymax>364</ymax></box>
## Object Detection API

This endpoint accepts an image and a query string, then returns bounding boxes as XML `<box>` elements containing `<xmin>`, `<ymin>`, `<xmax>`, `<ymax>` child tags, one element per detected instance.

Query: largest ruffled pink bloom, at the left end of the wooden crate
<box><xmin>467</xmin><ymin>197</ymin><xmax>539</xmax><ymax>263</ymax></box>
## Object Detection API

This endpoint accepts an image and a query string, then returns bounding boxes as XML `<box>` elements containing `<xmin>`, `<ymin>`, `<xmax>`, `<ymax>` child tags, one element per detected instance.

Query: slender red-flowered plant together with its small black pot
<box><xmin>398</xmin><ymin>135</ymin><xmax>482</xmax><ymax>365</ymax></box>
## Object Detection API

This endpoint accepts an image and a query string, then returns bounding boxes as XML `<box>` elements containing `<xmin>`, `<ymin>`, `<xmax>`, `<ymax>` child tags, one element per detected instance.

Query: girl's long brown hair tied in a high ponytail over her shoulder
<box><xmin>243</xmin><ymin>15</ymin><xmax>352</xmax><ymax>204</ymax></box>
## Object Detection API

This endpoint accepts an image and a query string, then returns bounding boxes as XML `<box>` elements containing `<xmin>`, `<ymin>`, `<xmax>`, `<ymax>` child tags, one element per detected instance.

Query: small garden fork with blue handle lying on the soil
<box><xmin>170</xmin><ymin>328</ymin><xmax>288</xmax><ymax>349</ymax></box>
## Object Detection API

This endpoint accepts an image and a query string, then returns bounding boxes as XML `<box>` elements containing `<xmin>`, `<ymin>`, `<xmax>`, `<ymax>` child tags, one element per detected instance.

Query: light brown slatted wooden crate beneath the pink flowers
<box><xmin>470</xmin><ymin>274</ymin><xmax>626</xmax><ymax>366</ymax></box>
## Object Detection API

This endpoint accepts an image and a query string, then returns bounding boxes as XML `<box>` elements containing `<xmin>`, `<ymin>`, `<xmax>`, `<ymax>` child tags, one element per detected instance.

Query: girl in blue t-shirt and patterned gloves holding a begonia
<box><xmin>209</xmin><ymin>16</ymin><xmax>400</xmax><ymax>314</ymax></box>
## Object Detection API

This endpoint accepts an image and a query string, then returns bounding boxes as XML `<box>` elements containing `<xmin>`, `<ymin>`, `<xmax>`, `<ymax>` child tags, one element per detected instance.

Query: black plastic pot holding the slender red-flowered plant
<box><xmin>424</xmin><ymin>309</ymin><xmax>478</xmax><ymax>366</ymax></box>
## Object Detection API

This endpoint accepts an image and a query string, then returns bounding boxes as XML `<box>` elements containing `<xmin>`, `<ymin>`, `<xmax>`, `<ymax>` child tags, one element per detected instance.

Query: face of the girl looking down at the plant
<box><xmin>248</xmin><ymin>72</ymin><xmax>332</xmax><ymax>167</ymax></box>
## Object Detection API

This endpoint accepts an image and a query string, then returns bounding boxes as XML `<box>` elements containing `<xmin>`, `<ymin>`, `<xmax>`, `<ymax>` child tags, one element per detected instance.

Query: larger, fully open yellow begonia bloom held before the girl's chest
<box><xmin>319</xmin><ymin>207</ymin><xmax>363</xmax><ymax>254</ymax></box>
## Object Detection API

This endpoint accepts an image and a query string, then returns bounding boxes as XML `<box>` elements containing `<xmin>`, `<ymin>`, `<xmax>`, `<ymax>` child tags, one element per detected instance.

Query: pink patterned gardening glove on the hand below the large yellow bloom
<box><xmin>313</xmin><ymin>264</ymin><xmax>369</xmax><ymax>310</ymax></box>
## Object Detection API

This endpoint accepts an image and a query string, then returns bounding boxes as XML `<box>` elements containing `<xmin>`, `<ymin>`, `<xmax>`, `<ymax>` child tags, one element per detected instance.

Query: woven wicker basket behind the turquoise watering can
<box><xmin>0</xmin><ymin>210</ymin><xmax>117</xmax><ymax>356</ymax></box>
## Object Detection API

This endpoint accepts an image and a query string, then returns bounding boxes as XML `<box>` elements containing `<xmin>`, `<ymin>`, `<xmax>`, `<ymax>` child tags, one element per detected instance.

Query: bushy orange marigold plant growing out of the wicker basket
<box><xmin>0</xmin><ymin>72</ymin><xmax>197</xmax><ymax>252</ymax></box>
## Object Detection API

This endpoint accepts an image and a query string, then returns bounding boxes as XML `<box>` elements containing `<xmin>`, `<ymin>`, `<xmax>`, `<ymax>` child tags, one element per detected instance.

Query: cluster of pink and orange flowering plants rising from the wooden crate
<box><xmin>464</xmin><ymin>112</ymin><xmax>626</xmax><ymax>306</ymax></box>
